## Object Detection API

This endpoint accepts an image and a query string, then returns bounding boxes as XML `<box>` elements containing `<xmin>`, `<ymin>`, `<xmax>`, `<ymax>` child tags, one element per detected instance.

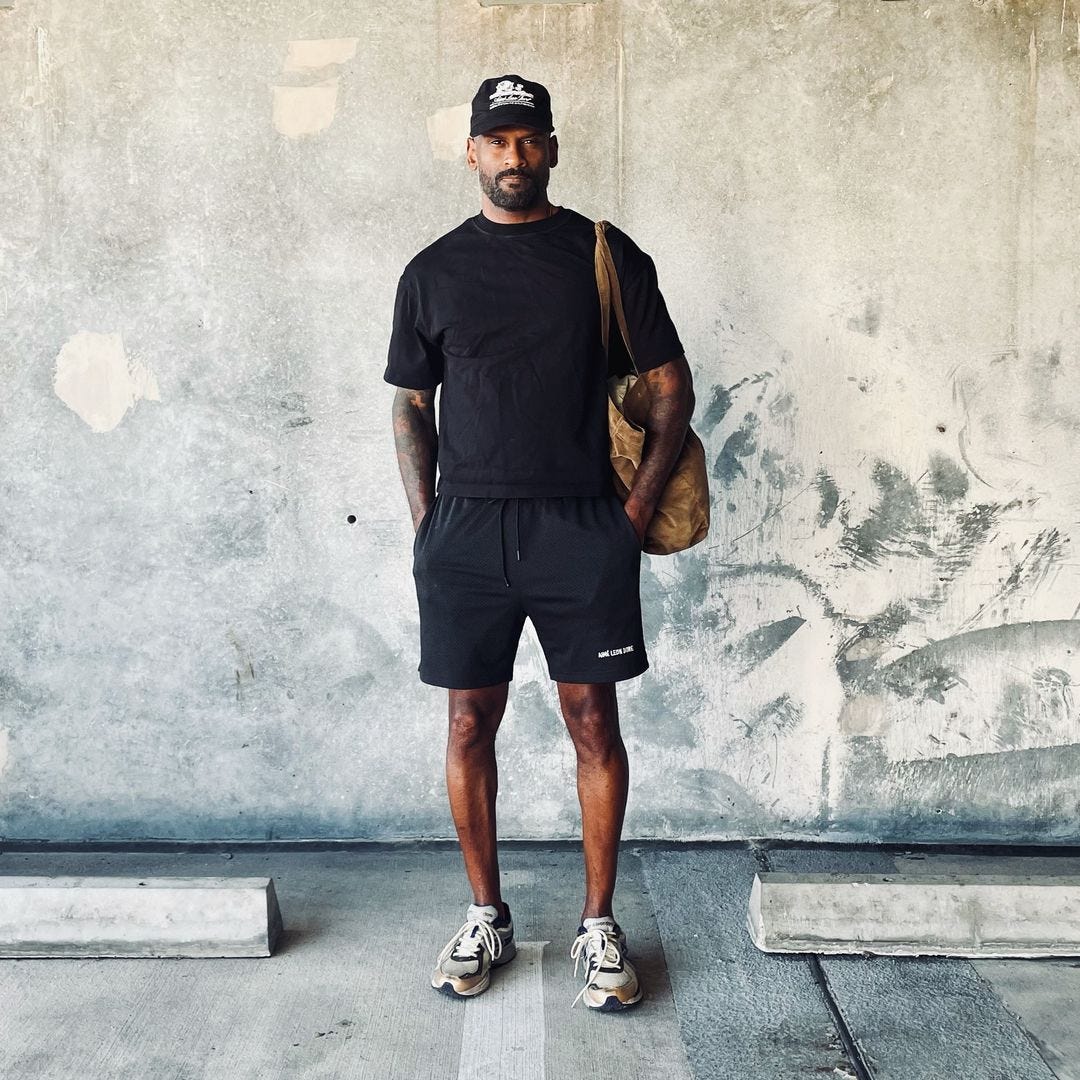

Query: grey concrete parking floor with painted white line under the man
<box><xmin>0</xmin><ymin>843</ymin><xmax>1080</xmax><ymax>1080</ymax></box>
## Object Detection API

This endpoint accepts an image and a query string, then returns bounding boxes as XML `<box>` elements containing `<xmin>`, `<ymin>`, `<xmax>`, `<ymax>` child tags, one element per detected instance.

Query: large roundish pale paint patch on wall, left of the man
<box><xmin>53</xmin><ymin>330</ymin><xmax>161</xmax><ymax>433</ymax></box>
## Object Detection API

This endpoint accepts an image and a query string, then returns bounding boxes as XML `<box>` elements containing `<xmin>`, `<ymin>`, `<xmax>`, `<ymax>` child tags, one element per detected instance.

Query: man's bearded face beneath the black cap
<box><xmin>465</xmin><ymin>127</ymin><xmax>558</xmax><ymax>210</ymax></box>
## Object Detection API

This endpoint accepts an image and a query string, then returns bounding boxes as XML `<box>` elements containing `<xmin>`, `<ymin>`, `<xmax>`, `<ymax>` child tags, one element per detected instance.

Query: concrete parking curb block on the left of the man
<box><xmin>0</xmin><ymin>877</ymin><xmax>283</xmax><ymax>958</ymax></box>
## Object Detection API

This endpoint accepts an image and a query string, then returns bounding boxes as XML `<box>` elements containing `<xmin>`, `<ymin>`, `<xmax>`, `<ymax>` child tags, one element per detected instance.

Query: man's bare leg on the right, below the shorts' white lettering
<box><xmin>556</xmin><ymin>683</ymin><xmax>630</xmax><ymax>920</ymax></box>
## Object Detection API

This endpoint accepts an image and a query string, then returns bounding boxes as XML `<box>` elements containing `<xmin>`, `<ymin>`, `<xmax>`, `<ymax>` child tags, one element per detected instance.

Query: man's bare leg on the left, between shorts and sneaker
<box><xmin>446</xmin><ymin>683</ymin><xmax>510</xmax><ymax>915</ymax></box>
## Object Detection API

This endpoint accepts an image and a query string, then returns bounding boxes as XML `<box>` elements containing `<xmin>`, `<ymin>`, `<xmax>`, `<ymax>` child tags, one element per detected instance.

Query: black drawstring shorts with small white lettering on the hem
<box><xmin>413</xmin><ymin>492</ymin><xmax>649</xmax><ymax>690</ymax></box>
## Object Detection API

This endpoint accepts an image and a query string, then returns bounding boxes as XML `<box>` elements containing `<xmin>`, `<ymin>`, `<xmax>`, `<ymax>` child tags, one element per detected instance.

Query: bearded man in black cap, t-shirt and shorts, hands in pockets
<box><xmin>384</xmin><ymin>75</ymin><xmax>694</xmax><ymax>1011</ymax></box>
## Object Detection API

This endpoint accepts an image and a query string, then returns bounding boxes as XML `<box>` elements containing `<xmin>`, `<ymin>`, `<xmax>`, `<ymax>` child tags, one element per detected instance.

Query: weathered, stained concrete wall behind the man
<box><xmin>0</xmin><ymin>0</ymin><xmax>1080</xmax><ymax>841</ymax></box>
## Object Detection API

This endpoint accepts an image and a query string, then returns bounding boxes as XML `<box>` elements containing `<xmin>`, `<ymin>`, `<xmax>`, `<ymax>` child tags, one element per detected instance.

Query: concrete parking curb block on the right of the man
<box><xmin>746</xmin><ymin>873</ymin><xmax>1080</xmax><ymax>957</ymax></box>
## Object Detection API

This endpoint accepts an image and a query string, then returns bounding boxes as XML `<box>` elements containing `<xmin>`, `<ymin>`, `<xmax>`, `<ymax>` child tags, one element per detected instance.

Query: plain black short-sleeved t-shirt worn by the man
<box><xmin>383</xmin><ymin>207</ymin><xmax>683</xmax><ymax>498</ymax></box>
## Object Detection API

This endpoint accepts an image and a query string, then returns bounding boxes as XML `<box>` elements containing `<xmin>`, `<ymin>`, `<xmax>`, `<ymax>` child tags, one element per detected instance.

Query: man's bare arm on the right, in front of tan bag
<box><xmin>624</xmin><ymin>356</ymin><xmax>694</xmax><ymax>543</ymax></box>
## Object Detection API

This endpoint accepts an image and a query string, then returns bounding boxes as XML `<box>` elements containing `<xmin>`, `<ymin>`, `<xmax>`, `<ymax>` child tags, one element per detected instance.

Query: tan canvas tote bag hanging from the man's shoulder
<box><xmin>595</xmin><ymin>221</ymin><xmax>710</xmax><ymax>555</ymax></box>
